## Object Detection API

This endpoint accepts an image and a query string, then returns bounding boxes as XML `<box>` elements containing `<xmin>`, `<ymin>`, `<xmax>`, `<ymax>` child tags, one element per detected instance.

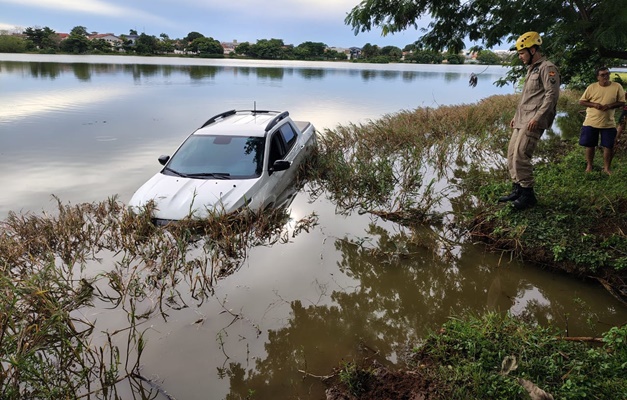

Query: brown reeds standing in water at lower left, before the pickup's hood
<box><xmin>0</xmin><ymin>194</ymin><xmax>317</xmax><ymax>399</ymax></box>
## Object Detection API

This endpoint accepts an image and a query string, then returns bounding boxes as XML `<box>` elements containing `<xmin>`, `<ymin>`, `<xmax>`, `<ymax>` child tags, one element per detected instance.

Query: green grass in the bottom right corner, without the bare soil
<box><xmin>410</xmin><ymin>313</ymin><xmax>627</xmax><ymax>400</ymax></box>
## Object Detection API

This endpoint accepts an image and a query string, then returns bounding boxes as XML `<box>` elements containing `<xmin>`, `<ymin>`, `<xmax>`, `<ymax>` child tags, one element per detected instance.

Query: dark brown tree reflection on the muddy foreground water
<box><xmin>212</xmin><ymin>220</ymin><xmax>625</xmax><ymax>399</ymax></box>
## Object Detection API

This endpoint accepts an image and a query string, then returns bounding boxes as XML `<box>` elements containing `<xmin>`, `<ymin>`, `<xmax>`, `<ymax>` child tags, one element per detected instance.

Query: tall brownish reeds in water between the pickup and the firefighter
<box><xmin>313</xmin><ymin>95</ymin><xmax>516</xmax><ymax>222</ymax></box>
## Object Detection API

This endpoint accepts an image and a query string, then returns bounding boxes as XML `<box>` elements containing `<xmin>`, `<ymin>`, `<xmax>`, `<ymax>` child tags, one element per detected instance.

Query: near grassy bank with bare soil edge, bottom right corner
<box><xmin>327</xmin><ymin>313</ymin><xmax>627</xmax><ymax>400</ymax></box>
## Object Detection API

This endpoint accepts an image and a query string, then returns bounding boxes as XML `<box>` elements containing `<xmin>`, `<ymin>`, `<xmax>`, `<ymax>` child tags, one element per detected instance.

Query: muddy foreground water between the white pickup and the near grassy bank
<box><xmin>105</xmin><ymin>188</ymin><xmax>627</xmax><ymax>399</ymax></box>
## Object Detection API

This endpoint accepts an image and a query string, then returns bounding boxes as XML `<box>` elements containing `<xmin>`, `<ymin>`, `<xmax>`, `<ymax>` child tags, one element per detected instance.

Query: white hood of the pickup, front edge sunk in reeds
<box><xmin>129</xmin><ymin>173</ymin><xmax>259</xmax><ymax>220</ymax></box>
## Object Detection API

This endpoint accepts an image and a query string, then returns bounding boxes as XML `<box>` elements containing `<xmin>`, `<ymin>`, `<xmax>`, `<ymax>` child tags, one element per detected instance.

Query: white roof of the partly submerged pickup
<box><xmin>193</xmin><ymin>110</ymin><xmax>282</xmax><ymax>137</ymax></box>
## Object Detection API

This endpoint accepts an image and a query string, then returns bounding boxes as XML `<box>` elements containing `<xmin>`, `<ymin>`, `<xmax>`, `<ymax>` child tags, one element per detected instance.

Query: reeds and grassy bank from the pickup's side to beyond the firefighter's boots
<box><xmin>313</xmin><ymin>90</ymin><xmax>627</xmax><ymax>304</ymax></box>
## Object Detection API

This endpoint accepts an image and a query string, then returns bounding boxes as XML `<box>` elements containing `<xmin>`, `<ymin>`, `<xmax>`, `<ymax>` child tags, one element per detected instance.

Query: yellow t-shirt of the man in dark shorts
<box><xmin>579</xmin><ymin>82</ymin><xmax>625</xmax><ymax>129</ymax></box>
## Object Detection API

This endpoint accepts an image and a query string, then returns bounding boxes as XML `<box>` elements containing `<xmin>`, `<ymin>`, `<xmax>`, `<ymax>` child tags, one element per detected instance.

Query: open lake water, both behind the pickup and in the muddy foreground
<box><xmin>0</xmin><ymin>54</ymin><xmax>627</xmax><ymax>399</ymax></box>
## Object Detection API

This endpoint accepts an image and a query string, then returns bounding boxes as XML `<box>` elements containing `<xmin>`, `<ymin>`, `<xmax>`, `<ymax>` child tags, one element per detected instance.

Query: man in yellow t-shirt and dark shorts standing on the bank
<box><xmin>579</xmin><ymin>67</ymin><xmax>625</xmax><ymax>175</ymax></box>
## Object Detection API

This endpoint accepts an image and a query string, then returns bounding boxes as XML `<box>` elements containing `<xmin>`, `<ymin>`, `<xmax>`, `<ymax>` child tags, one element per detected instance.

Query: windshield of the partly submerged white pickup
<box><xmin>164</xmin><ymin>135</ymin><xmax>265</xmax><ymax>179</ymax></box>
